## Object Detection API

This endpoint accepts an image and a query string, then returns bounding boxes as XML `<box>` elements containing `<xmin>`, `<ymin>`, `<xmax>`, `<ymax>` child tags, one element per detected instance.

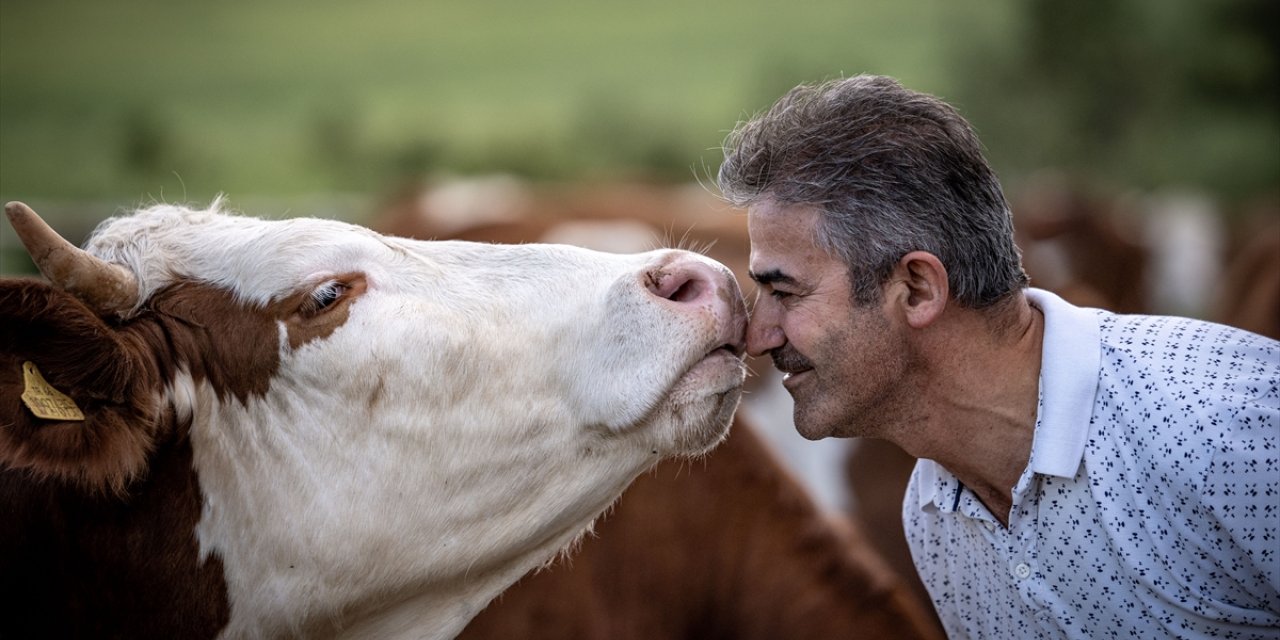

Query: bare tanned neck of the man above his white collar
<box><xmin>899</xmin><ymin>298</ymin><xmax>1044</xmax><ymax>526</ymax></box>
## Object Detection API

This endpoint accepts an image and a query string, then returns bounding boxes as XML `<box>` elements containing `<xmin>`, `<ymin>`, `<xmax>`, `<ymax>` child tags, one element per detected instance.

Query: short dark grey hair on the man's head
<box><xmin>718</xmin><ymin>76</ymin><xmax>1028</xmax><ymax>308</ymax></box>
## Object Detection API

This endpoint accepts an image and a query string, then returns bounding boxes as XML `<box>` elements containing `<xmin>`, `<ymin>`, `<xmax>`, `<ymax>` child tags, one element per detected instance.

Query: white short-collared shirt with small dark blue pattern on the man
<box><xmin>902</xmin><ymin>289</ymin><xmax>1280</xmax><ymax>639</ymax></box>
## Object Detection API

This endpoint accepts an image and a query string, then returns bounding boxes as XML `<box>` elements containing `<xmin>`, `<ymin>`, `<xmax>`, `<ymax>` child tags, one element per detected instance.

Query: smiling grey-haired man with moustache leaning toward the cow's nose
<box><xmin>718</xmin><ymin>76</ymin><xmax>1280</xmax><ymax>639</ymax></box>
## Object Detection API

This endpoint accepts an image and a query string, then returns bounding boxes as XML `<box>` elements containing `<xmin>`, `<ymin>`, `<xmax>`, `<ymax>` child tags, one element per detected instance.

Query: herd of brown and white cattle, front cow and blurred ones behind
<box><xmin>0</xmin><ymin>172</ymin><xmax>1280</xmax><ymax>639</ymax></box>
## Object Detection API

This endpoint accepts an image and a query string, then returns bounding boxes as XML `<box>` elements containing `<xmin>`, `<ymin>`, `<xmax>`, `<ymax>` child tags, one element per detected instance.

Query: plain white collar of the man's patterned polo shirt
<box><xmin>916</xmin><ymin>288</ymin><xmax>1102</xmax><ymax>508</ymax></box>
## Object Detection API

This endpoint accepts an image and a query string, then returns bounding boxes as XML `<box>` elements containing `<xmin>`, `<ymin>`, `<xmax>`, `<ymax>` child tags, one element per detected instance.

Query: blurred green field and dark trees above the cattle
<box><xmin>0</xmin><ymin>0</ymin><xmax>1280</xmax><ymax>213</ymax></box>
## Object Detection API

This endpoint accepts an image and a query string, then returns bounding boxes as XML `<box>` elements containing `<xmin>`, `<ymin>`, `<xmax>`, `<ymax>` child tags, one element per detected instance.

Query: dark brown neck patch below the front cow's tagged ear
<box><xmin>0</xmin><ymin>416</ymin><xmax>230</xmax><ymax>639</ymax></box>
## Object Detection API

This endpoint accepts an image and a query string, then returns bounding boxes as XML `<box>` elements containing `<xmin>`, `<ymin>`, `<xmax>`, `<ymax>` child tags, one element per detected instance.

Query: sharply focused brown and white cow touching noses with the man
<box><xmin>0</xmin><ymin>197</ymin><xmax>745</xmax><ymax>639</ymax></box>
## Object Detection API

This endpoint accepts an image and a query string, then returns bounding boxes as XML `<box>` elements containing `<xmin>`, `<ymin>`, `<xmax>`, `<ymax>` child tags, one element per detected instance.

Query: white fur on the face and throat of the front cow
<box><xmin>80</xmin><ymin>206</ymin><xmax>744</xmax><ymax>637</ymax></box>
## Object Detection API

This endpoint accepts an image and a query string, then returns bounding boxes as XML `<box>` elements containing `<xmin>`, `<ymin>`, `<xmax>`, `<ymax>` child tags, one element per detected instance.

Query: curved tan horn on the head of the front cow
<box><xmin>4</xmin><ymin>202</ymin><xmax>138</xmax><ymax>315</ymax></box>
